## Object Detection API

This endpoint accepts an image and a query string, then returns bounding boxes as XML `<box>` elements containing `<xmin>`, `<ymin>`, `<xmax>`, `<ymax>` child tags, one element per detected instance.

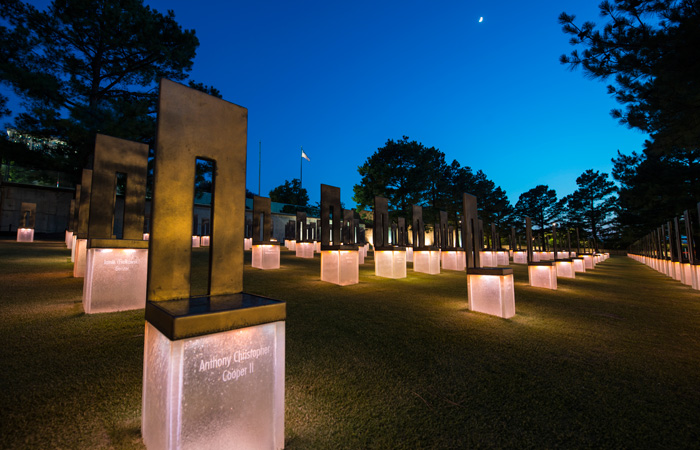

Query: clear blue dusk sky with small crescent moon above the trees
<box><xmin>3</xmin><ymin>0</ymin><xmax>647</xmax><ymax>207</ymax></box>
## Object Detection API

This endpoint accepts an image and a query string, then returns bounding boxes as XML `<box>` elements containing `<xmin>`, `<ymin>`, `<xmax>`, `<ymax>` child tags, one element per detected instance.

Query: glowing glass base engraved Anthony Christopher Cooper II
<box><xmin>141</xmin><ymin>321</ymin><xmax>285</xmax><ymax>450</ymax></box>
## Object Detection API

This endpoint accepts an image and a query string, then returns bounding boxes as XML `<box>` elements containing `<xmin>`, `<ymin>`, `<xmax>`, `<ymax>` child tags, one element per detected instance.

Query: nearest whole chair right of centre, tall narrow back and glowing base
<box><xmin>462</xmin><ymin>193</ymin><xmax>515</xmax><ymax>319</ymax></box>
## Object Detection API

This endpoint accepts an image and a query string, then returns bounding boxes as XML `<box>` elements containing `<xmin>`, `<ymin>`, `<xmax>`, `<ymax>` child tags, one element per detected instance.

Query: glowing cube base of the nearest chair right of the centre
<box><xmin>467</xmin><ymin>269</ymin><xmax>515</xmax><ymax>319</ymax></box>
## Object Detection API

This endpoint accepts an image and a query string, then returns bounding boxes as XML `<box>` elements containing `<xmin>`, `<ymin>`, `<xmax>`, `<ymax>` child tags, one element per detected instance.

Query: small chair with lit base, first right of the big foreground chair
<box><xmin>252</xmin><ymin>195</ymin><xmax>280</xmax><ymax>270</ymax></box>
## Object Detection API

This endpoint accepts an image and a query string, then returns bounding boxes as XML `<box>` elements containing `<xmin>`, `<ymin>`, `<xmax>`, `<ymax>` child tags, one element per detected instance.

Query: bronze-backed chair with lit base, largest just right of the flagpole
<box><xmin>321</xmin><ymin>184</ymin><xmax>360</xmax><ymax>286</ymax></box>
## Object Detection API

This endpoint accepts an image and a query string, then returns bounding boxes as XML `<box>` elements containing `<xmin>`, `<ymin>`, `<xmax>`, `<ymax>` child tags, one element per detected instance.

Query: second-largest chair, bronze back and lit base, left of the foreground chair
<box><xmin>81</xmin><ymin>134</ymin><xmax>148</xmax><ymax>314</ymax></box>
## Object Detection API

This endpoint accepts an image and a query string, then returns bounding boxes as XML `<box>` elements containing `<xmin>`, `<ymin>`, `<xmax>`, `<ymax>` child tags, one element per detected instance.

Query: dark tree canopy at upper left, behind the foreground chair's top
<box><xmin>0</xmin><ymin>0</ymin><xmax>218</xmax><ymax>179</ymax></box>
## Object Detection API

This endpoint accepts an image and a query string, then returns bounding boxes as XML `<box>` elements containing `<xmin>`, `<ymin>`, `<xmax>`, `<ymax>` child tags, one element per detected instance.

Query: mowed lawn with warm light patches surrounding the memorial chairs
<box><xmin>0</xmin><ymin>241</ymin><xmax>700</xmax><ymax>449</ymax></box>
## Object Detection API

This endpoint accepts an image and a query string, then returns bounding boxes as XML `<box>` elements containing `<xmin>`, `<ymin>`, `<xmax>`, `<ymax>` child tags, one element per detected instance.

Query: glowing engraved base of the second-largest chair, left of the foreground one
<box><xmin>83</xmin><ymin>248</ymin><xmax>148</xmax><ymax>314</ymax></box>
